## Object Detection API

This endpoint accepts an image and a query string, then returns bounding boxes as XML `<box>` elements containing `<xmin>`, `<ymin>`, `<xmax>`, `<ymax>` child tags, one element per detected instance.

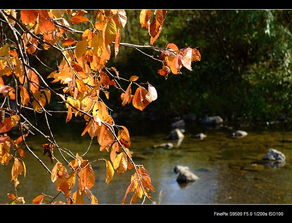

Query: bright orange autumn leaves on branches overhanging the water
<box><xmin>0</xmin><ymin>10</ymin><xmax>201</xmax><ymax>204</ymax></box>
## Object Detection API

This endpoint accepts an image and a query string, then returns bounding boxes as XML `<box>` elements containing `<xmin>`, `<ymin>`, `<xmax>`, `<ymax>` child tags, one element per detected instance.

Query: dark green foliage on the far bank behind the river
<box><xmin>114</xmin><ymin>10</ymin><xmax>292</xmax><ymax>120</ymax></box>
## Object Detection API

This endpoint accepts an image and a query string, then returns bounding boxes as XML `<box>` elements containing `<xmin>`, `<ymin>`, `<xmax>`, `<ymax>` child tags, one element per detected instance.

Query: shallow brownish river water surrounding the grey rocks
<box><xmin>0</xmin><ymin>119</ymin><xmax>292</xmax><ymax>204</ymax></box>
